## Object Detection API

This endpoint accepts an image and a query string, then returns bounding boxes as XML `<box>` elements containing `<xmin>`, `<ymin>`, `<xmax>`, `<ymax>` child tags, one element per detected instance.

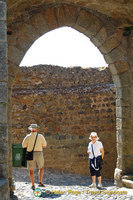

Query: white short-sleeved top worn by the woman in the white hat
<box><xmin>88</xmin><ymin>141</ymin><xmax>103</xmax><ymax>159</ymax></box>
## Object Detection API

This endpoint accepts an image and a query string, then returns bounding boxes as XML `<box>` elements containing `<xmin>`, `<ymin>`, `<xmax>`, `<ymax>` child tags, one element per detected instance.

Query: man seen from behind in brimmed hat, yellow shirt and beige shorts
<box><xmin>22</xmin><ymin>124</ymin><xmax>47</xmax><ymax>190</ymax></box>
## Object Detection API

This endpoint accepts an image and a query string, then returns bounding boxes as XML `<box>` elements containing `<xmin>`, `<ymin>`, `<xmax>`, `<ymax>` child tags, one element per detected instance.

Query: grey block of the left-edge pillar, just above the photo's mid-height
<box><xmin>0</xmin><ymin>82</ymin><xmax>8</xmax><ymax>103</ymax></box>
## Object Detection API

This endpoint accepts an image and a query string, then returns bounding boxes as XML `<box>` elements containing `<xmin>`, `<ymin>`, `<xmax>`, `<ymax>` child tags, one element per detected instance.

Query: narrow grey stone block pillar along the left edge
<box><xmin>0</xmin><ymin>0</ymin><xmax>9</xmax><ymax>200</ymax></box>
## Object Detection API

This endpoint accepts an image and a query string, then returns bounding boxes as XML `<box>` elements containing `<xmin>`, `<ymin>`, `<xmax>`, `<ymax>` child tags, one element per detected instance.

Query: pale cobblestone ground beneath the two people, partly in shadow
<box><xmin>11</xmin><ymin>168</ymin><xmax>133</xmax><ymax>200</ymax></box>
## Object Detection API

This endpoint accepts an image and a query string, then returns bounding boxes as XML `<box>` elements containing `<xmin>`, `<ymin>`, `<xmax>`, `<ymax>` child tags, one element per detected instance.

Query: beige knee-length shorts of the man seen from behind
<box><xmin>27</xmin><ymin>152</ymin><xmax>44</xmax><ymax>170</ymax></box>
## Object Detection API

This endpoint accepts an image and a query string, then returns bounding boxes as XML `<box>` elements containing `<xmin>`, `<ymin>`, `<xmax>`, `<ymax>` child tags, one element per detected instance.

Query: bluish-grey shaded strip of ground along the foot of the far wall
<box><xmin>13</xmin><ymin>168</ymin><xmax>114</xmax><ymax>187</ymax></box>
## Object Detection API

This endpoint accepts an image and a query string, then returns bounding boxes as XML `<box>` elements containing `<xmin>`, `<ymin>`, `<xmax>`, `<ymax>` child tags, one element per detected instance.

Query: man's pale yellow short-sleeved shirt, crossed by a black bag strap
<box><xmin>22</xmin><ymin>132</ymin><xmax>47</xmax><ymax>151</ymax></box>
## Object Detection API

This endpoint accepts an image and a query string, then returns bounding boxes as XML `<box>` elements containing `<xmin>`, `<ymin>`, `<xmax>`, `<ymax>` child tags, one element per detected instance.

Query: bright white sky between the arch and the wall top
<box><xmin>20</xmin><ymin>27</ymin><xmax>107</xmax><ymax>68</ymax></box>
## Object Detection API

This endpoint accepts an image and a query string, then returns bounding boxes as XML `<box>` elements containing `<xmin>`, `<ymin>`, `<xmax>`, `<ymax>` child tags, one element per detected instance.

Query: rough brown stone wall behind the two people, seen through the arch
<box><xmin>12</xmin><ymin>66</ymin><xmax>117</xmax><ymax>178</ymax></box>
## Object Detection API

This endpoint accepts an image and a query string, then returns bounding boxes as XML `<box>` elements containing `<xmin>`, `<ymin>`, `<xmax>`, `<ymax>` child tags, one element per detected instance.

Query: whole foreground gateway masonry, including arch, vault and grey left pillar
<box><xmin>0</xmin><ymin>0</ymin><xmax>133</xmax><ymax>199</ymax></box>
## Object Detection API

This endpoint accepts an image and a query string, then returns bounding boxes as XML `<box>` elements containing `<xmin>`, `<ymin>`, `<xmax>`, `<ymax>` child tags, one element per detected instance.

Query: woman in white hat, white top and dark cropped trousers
<box><xmin>87</xmin><ymin>132</ymin><xmax>104</xmax><ymax>188</ymax></box>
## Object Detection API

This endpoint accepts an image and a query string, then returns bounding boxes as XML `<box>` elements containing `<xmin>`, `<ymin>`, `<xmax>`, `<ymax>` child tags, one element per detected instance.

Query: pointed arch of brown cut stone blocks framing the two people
<box><xmin>8</xmin><ymin>4</ymin><xmax>133</xmax><ymax>191</ymax></box>
